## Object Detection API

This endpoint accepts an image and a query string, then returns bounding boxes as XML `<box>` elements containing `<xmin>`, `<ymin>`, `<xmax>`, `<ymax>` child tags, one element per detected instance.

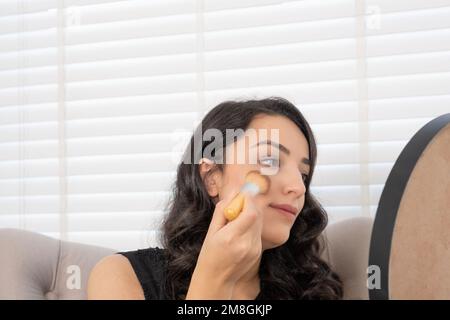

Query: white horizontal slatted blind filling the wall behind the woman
<box><xmin>0</xmin><ymin>0</ymin><xmax>450</xmax><ymax>250</ymax></box>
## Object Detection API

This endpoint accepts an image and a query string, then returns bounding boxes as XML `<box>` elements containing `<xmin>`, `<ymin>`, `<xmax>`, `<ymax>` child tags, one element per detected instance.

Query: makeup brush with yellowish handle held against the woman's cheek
<box><xmin>224</xmin><ymin>171</ymin><xmax>270</xmax><ymax>221</ymax></box>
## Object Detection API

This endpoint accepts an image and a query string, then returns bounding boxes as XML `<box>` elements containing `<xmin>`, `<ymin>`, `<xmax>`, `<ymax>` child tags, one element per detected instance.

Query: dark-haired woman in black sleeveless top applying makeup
<box><xmin>88</xmin><ymin>98</ymin><xmax>343</xmax><ymax>300</ymax></box>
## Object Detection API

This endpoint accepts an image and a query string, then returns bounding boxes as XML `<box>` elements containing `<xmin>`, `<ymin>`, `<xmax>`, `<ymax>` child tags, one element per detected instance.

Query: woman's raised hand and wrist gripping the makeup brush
<box><xmin>186</xmin><ymin>190</ymin><xmax>263</xmax><ymax>299</ymax></box>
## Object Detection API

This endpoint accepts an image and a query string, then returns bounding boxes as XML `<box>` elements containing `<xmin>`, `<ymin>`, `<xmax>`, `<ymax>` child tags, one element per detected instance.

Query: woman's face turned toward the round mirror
<box><xmin>207</xmin><ymin>114</ymin><xmax>309</xmax><ymax>250</ymax></box>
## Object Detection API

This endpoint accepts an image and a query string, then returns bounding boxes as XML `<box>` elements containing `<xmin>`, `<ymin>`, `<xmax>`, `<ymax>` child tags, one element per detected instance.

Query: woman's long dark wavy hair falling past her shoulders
<box><xmin>161</xmin><ymin>97</ymin><xmax>343</xmax><ymax>299</ymax></box>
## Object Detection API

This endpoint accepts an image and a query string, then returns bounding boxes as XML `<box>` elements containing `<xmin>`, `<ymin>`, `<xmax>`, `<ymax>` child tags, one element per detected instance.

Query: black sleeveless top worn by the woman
<box><xmin>118</xmin><ymin>247</ymin><xmax>264</xmax><ymax>300</ymax></box>
